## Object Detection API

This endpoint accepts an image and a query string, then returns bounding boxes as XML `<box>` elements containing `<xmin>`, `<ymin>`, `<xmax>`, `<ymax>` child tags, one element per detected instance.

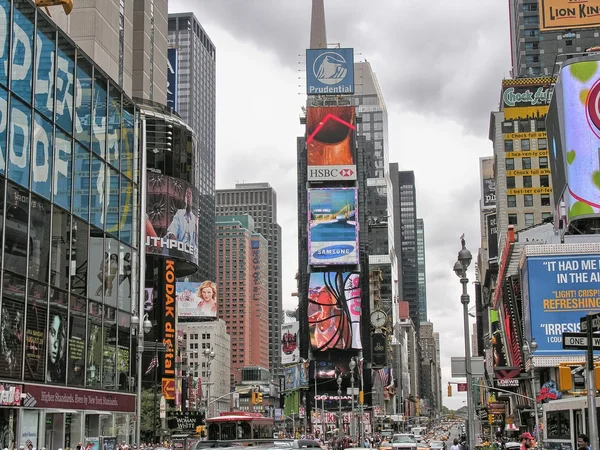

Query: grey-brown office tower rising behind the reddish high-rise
<box><xmin>215</xmin><ymin>183</ymin><xmax>283</xmax><ymax>375</ymax></box>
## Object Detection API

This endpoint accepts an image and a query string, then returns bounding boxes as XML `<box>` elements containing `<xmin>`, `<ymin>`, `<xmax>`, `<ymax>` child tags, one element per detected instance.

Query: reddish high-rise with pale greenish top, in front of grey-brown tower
<box><xmin>216</xmin><ymin>215</ymin><xmax>269</xmax><ymax>383</ymax></box>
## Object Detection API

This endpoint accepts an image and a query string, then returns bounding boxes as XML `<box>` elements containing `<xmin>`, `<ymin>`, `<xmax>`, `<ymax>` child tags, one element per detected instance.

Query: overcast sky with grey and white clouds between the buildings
<box><xmin>169</xmin><ymin>0</ymin><xmax>510</xmax><ymax>408</ymax></box>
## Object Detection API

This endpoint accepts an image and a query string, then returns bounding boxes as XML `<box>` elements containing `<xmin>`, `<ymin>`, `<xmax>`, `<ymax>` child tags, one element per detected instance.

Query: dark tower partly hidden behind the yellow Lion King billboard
<box><xmin>509</xmin><ymin>0</ymin><xmax>600</xmax><ymax>78</ymax></box>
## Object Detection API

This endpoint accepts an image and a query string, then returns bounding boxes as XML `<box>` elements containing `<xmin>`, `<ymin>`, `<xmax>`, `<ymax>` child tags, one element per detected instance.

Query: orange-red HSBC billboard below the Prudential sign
<box><xmin>306</xmin><ymin>106</ymin><xmax>356</xmax><ymax>181</ymax></box>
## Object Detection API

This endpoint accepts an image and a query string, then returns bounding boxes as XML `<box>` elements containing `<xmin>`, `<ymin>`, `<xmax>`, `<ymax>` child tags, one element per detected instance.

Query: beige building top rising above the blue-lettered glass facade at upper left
<box><xmin>51</xmin><ymin>0</ymin><xmax>168</xmax><ymax>104</ymax></box>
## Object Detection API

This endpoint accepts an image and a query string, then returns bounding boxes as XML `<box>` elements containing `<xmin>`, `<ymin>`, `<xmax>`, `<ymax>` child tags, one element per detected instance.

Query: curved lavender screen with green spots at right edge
<box><xmin>556</xmin><ymin>61</ymin><xmax>600</xmax><ymax>221</ymax></box>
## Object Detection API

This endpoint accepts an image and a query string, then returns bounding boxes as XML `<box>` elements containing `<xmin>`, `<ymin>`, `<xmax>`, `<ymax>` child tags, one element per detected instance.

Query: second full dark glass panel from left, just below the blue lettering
<box><xmin>29</xmin><ymin>196</ymin><xmax>52</xmax><ymax>283</ymax></box>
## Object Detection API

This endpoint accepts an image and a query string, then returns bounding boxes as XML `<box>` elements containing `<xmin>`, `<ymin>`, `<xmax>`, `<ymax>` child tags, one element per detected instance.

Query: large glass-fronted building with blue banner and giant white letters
<box><xmin>0</xmin><ymin>0</ymin><xmax>140</xmax><ymax>448</ymax></box>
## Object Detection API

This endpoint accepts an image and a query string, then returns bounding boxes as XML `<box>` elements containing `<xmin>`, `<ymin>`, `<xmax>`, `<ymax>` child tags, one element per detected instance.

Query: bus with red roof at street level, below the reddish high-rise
<box><xmin>206</xmin><ymin>411</ymin><xmax>274</xmax><ymax>441</ymax></box>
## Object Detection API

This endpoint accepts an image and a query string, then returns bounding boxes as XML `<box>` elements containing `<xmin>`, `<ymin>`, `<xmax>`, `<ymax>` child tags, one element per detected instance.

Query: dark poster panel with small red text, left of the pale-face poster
<box><xmin>25</xmin><ymin>281</ymin><xmax>48</xmax><ymax>381</ymax></box>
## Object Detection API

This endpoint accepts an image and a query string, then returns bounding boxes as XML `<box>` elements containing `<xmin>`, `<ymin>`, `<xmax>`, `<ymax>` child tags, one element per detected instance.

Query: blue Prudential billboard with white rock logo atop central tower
<box><xmin>306</xmin><ymin>48</ymin><xmax>354</xmax><ymax>95</ymax></box>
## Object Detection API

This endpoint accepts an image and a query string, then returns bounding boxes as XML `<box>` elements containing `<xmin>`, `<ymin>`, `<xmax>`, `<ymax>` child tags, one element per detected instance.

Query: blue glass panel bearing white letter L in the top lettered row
<box><xmin>35</xmin><ymin>14</ymin><xmax>56</xmax><ymax>120</ymax></box>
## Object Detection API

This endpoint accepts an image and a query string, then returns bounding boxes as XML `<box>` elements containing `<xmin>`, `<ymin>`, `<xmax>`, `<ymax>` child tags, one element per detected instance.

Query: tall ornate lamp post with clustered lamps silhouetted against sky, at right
<box><xmin>454</xmin><ymin>235</ymin><xmax>475</xmax><ymax>450</ymax></box>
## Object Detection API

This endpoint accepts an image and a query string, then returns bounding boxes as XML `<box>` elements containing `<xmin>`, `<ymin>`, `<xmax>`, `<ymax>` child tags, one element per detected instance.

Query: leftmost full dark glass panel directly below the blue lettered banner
<box><xmin>0</xmin><ymin>183</ymin><xmax>29</xmax><ymax>272</ymax></box>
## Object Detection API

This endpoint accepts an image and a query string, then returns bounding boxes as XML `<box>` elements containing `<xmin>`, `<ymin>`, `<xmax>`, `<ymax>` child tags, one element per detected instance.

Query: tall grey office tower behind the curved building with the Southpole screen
<box><xmin>168</xmin><ymin>13</ymin><xmax>217</xmax><ymax>280</ymax></box>
